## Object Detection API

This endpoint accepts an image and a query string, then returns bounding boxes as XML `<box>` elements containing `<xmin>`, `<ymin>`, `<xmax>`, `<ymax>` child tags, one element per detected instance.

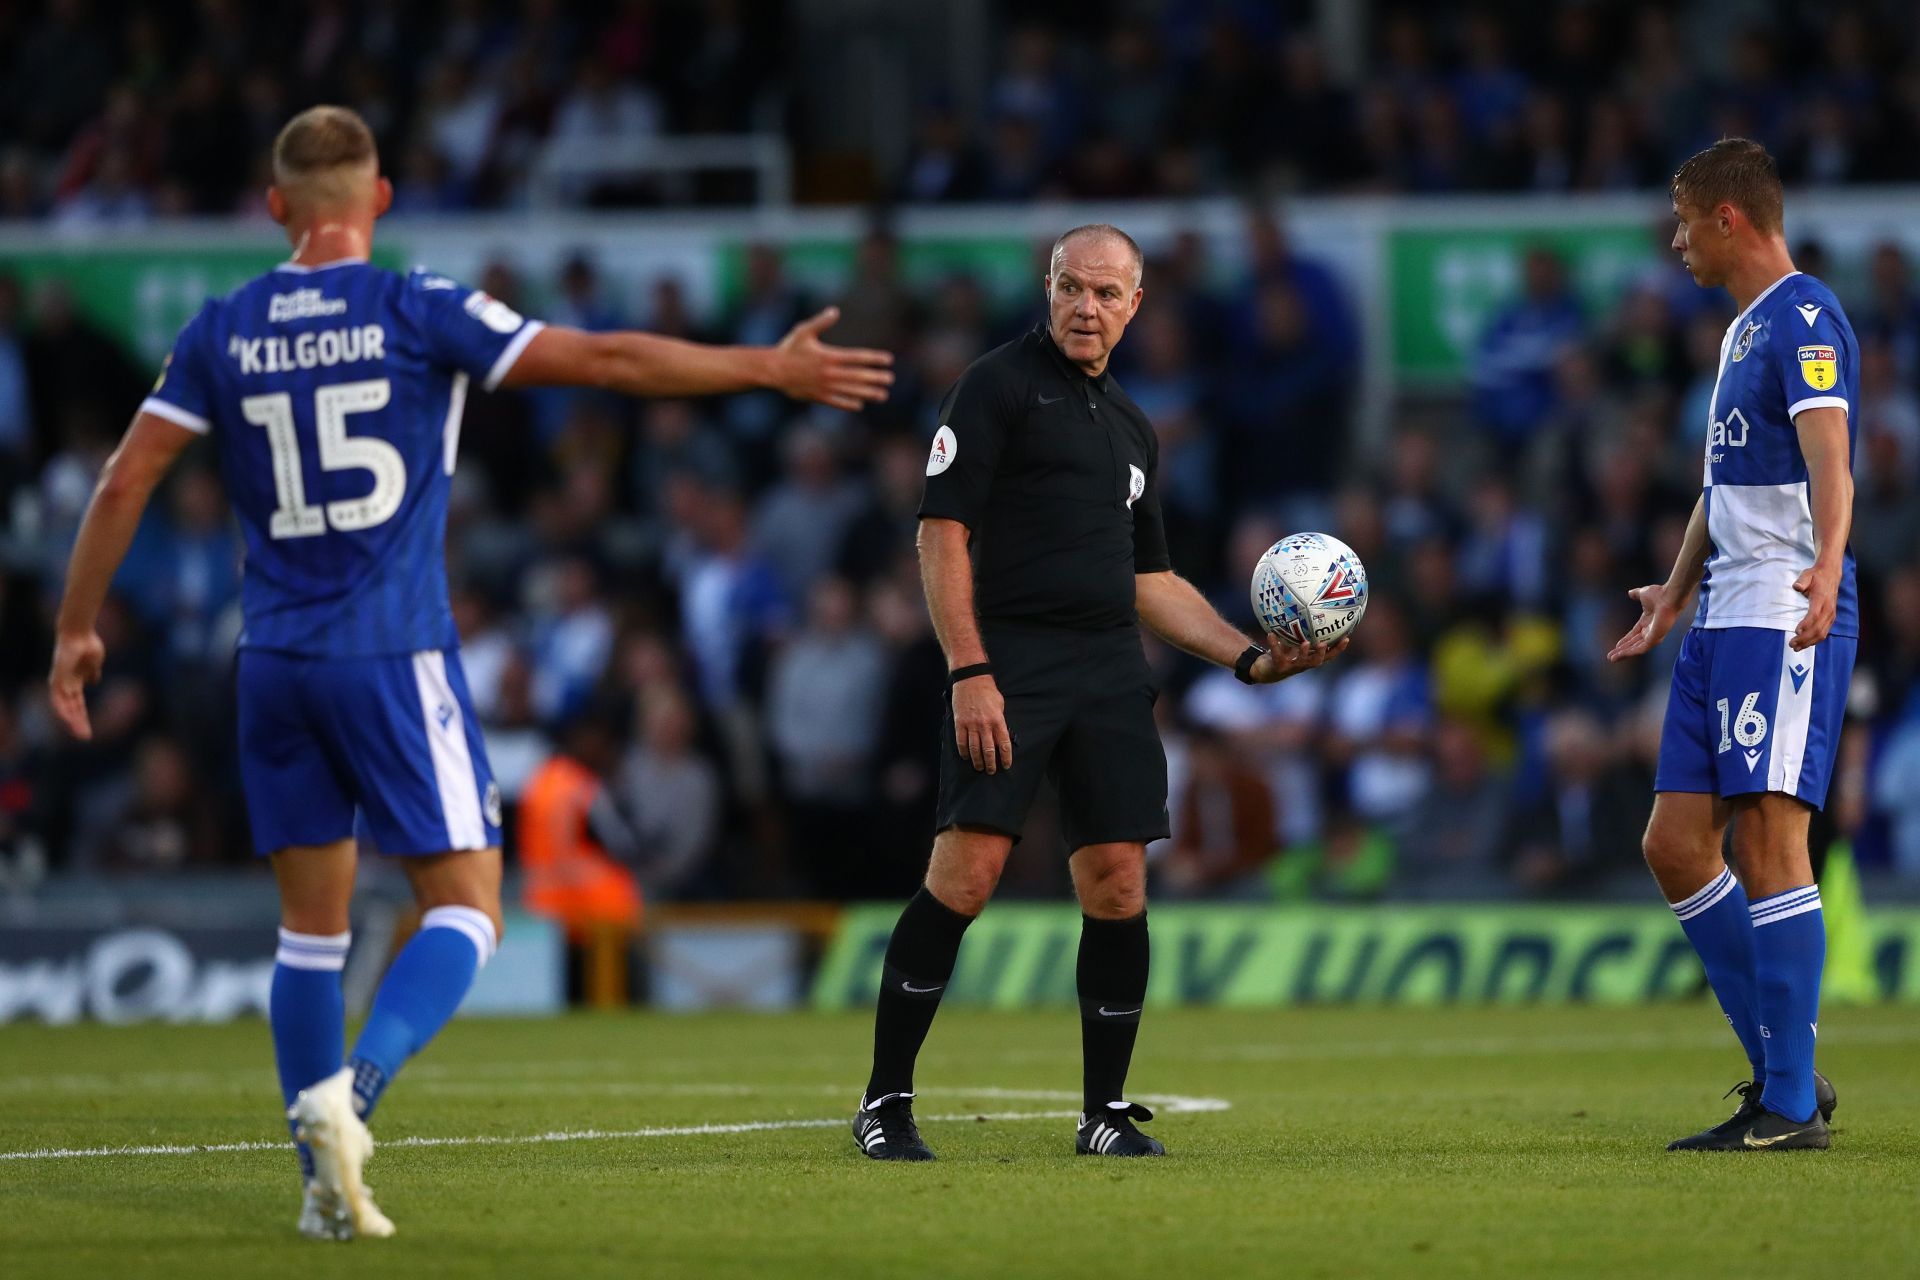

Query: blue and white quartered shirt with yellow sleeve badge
<box><xmin>1693</xmin><ymin>271</ymin><xmax>1860</xmax><ymax>635</ymax></box>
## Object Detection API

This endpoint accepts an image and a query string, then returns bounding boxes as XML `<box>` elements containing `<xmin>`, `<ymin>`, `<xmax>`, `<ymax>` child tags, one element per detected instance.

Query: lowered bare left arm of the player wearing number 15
<box><xmin>46</xmin><ymin>413</ymin><xmax>198</xmax><ymax>741</ymax></box>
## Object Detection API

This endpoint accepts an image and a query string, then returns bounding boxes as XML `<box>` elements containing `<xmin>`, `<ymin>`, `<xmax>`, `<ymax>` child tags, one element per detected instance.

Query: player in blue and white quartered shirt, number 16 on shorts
<box><xmin>1607</xmin><ymin>138</ymin><xmax>1860</xmax><ymax>1151</ymax></box>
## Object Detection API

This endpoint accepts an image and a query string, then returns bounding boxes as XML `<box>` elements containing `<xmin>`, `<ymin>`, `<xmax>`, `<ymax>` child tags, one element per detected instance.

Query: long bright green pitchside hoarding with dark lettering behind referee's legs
<box><xmin>812</xmin><ymin>904</ymin><xmax>1920</xmax><ymax>1009</ymax></box>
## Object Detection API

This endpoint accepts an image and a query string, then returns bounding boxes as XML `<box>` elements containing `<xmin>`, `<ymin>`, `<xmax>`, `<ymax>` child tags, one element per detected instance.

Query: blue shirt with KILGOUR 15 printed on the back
<box><xmin>142</xmin><ymin>259</ymin><xmax>541</xmax><ymax>658</ymax></box>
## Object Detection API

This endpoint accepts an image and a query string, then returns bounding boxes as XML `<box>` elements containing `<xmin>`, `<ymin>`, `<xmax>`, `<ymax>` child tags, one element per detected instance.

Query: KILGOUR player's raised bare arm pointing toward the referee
<box><xmin>501</xmin><ymin>307</ymin><xmax>893</xmax><ymax>409</ymax></box>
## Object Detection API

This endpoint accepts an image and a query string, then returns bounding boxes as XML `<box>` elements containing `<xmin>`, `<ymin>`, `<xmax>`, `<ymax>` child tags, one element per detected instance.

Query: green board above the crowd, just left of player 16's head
<box><xmin>1384</xmin><ymin>223</ymin><xmax>1659</xmax><ymax>384</ymax></box>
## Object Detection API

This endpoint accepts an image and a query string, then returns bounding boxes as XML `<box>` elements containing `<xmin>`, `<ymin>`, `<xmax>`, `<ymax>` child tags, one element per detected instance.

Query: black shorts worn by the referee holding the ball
<box><xmin>935</xmin><ymin>622</ymin><xmax>1169</xmax><ymax>850</ymax></box>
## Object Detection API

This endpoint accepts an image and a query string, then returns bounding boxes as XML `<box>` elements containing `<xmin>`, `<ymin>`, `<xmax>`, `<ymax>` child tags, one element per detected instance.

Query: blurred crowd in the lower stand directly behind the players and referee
<box><xmin>0</xmin><ymin>215</ymin><xmax>1920</xmax><ymax>898</ymax></box>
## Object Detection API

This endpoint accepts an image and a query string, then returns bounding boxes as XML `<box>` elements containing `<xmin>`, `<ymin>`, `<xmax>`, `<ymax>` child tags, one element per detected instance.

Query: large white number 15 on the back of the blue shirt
<box><xmin>240</xmin><ymin>378</ymin><xmax>407</xmax><ymax>537</ymax></box>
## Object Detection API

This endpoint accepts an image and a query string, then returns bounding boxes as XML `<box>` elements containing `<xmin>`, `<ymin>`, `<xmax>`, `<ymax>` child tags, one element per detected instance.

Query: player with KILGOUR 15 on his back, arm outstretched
<box><xmin>50</xmin><ymin>107</ymin><xmax>893</xmax><ymax>1240</ymax></box>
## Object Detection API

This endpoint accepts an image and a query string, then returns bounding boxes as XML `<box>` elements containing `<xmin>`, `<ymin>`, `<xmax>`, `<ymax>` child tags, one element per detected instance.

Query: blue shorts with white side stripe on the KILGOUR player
<box><xmin>238</xmin><ymin>649</ymin><xmax>499</xmax><ymax>854</ymax></box>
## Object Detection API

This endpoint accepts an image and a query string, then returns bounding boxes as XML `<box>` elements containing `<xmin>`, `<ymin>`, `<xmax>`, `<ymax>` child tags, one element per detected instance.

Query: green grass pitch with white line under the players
<box><xmin>0</xmin><ymin>1004</ymin><xmax>1920</xmax><ymax>1280</ymax></box>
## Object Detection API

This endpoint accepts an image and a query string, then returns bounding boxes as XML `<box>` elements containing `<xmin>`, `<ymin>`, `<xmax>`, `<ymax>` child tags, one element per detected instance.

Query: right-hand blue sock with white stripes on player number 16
<box><xmin>1753</xmin><ymin>885</ymin><xmax>1826</xmax><ymax>1121</ymax></box>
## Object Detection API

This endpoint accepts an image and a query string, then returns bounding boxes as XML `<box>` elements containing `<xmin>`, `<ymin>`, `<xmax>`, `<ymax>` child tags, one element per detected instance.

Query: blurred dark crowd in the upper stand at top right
<box><xmin>899</xmin><ymin>0</ymin><xmax>1920</xmax><ymax>200</ymax></box>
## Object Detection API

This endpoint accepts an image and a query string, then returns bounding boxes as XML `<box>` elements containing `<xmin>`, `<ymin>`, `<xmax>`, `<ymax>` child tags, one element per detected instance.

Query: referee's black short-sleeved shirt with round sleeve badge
<box><xmin>920</xmin><ymin>322</ymin><xmax>1171</xmax><ymax>629</ymax></box>
